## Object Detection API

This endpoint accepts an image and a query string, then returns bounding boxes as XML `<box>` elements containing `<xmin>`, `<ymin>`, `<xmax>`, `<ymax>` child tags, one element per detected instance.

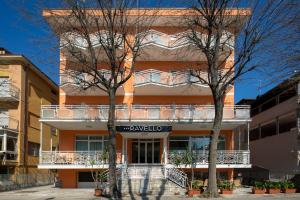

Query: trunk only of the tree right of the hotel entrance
<box><xmin>207</xmin><ymin>97</ymin><xmax>224</xmax><ymax>197</ymax></box>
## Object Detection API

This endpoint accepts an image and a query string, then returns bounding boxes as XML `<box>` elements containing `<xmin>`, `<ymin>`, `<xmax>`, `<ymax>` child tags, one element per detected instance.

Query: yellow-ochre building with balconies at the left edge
<box><xmin>0</xmin><ymin>48</ymin><xmax>58</xmax><ymax>176</ymax></box>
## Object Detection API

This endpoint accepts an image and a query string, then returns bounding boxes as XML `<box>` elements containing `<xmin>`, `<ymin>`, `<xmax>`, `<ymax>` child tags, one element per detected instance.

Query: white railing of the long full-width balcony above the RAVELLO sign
<box><xmin>41</xmin><ymin>105</ymin><xmax>250</xmax><ymax>122</ymax></box>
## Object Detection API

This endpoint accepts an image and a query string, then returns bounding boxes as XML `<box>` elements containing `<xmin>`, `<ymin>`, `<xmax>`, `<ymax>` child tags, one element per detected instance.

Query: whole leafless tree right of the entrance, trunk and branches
<box><xmin>184</xmin><ymin>0</ymin><xmax>296</xmax><ymax>197</ymax></box>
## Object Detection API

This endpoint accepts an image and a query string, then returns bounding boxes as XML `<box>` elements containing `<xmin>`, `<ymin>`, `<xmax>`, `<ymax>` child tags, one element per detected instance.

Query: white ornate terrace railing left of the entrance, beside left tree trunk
<box><xmin>39</xmin><ymin>151</ymin><xmax>107</xmax><ymax>168</ymax></box>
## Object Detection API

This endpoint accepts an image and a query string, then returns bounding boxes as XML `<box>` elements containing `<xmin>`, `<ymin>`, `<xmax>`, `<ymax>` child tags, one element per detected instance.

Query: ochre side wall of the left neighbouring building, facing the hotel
<box><xmin>26</xmin><ymin>67</ymin><xmax>58</xmax><ymax>173</ymax></box>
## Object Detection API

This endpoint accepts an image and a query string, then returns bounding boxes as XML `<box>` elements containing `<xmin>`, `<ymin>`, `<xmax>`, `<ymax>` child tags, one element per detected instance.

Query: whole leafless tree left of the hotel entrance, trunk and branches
<box><xmin>45</xmin><ymin>0</ymin><xmax>155</xmax><ymax>198</ymax></box>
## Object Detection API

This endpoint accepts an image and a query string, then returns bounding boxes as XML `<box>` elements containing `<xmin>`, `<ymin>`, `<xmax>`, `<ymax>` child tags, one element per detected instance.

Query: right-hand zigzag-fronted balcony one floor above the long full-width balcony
<box><xmin>134</xmin><ymin>69</ymin><xmax>211</xmax><ymax>95</ymax></box>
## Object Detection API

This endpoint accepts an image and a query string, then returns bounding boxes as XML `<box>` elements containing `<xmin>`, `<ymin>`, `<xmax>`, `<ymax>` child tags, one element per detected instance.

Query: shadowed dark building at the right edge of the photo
<box><xmin>238</xmin><ymin>73</ymin><xmax>300</xmax><ymax>179</ymax></box>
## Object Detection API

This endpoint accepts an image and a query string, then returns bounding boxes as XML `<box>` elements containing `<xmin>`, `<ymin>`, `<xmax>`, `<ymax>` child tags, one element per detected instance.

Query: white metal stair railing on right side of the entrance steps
<box><xmin>165</xmin><ymin>167</ymin><xmax>188</xmax><ymax>188</ymax></box>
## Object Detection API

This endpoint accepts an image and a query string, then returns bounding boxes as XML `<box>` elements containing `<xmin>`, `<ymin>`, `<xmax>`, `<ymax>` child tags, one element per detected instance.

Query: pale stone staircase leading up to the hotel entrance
<box><xmin>119</xmin><ymin>165</ymin><xmax>186</xmax><ymax>196</ymax></box>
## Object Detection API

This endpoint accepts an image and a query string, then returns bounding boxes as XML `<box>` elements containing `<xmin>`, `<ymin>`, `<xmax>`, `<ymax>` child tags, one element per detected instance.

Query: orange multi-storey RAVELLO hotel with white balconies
<box><xmin>39</xmin><ymin>9</ymin><xmax>251</xmax><ymax>190</ymax></box>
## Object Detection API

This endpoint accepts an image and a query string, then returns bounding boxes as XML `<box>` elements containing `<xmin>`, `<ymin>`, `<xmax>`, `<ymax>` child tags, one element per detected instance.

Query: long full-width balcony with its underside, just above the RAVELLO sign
<box><xmin>41</xmin><ymin>105</ymin><xmax>250</xmax><ymax>130</ymax></box>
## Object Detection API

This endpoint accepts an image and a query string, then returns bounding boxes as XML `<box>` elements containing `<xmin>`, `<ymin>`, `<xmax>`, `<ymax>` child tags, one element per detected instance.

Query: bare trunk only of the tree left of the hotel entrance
<box><xmin>107</xmin><ymin>89</ymin><xmax>119</xmax><ymax>199</ymax></box>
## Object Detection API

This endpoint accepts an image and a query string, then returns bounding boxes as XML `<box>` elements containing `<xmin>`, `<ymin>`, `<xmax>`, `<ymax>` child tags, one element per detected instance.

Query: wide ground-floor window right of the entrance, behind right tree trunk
<box><xmin>169</xmin><ymin>136</ymin><xmax>226</xmax><ymax>151</ymax></box>
